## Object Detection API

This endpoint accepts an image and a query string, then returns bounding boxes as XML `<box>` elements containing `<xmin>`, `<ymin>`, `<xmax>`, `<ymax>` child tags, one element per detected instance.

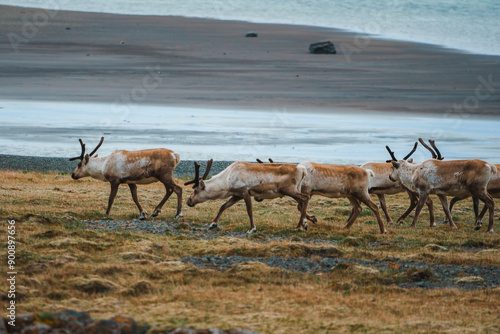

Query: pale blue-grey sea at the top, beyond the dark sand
<box><xmin>0</xmin><ymin>0</ymin><xmax>500</xmax><ymax>55</ymax></box>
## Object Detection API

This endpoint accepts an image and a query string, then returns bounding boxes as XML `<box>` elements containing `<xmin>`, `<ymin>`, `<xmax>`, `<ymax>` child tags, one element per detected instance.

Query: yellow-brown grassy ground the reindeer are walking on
<box><xmin>0</xmin><ymin>171</ymin><xmax>500</xmax><ymax>333</ymax></box>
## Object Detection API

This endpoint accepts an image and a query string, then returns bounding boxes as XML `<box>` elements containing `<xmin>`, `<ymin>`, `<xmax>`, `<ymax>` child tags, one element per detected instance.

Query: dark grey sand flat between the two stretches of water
<box><xmin>0</xmin><ymin>6</ymin><xmax>500</xmax><ymax>115</ymax></box>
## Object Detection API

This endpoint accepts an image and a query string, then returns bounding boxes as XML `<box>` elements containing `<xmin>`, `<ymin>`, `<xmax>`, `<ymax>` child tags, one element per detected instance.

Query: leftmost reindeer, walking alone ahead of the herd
<box><xmin>69</xmin><ymin>137</ymin><xmax>182</xmax><ymax>220</ymax></box>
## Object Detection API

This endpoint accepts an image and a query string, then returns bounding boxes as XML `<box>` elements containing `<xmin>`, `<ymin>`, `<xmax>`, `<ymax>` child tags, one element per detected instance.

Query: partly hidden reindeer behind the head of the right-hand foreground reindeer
<box><xmin>361</xmin><ymin>143</ymin><xmax>435</xmax><ymax>225</ymax></box>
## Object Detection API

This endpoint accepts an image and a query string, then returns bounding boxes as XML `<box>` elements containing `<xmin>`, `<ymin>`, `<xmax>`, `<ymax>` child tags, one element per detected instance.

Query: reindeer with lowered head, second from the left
<box><xmin>184</xmin><ymin>159</ymin><xmax>309</xmax><ymax>234</ymax></box>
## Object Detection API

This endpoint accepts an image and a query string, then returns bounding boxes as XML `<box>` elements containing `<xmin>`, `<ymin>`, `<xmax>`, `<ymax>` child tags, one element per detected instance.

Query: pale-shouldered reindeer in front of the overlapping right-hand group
<box><xmin>389</xmin><ymin>144</ymin><xmax>497</xmax><ymax>232</ymax></box>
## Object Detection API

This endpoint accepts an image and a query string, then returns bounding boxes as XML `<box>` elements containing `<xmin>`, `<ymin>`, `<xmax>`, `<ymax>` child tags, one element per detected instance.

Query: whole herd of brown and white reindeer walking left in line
<box><xmin>70</xmin><ymin>137</ymin><xmax>500</xmax><ymax>233</ymax></box>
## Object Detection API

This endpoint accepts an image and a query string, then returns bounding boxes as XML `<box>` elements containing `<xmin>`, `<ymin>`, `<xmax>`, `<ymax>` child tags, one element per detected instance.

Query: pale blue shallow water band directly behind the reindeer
<box><xmin>0</xmin><ymin>100</ymin><xmax>500</xmax><ymax>164</ymax></box>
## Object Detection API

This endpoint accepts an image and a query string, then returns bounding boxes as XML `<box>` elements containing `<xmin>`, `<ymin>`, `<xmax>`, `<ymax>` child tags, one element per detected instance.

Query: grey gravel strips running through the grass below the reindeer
<box><xmin>84</xmin><ymin>220</ymin><xmax>500</xmax><ymax>289</ymax></box>
